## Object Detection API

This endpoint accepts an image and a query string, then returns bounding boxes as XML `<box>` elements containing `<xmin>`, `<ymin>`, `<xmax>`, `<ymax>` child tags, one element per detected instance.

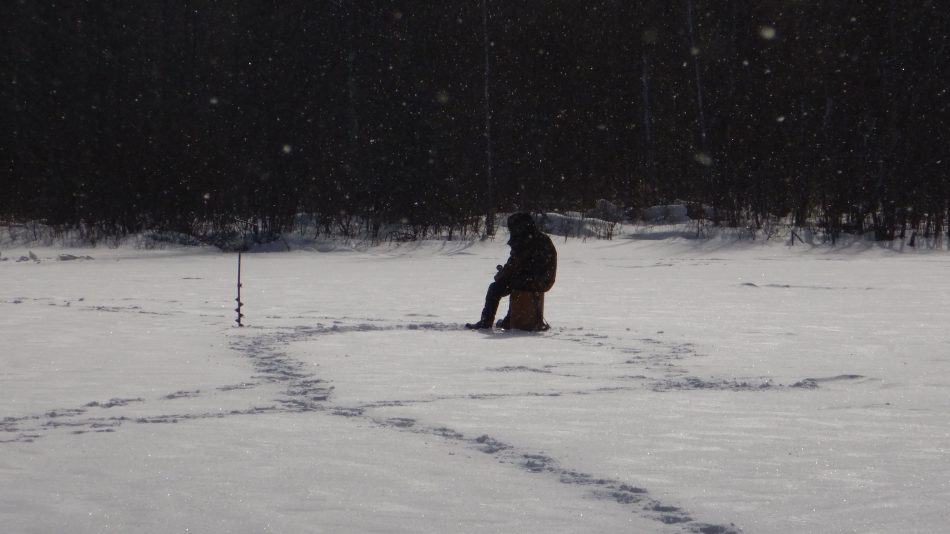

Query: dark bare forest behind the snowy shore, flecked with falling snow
<box><xmin>0</xmin><ymin>0</ymin><xmax>950</xmax><ymax>243</ymax></box>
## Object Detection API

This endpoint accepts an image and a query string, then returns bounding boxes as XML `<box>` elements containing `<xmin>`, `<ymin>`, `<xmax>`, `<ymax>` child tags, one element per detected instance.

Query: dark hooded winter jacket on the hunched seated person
<box><xmin>495</xmin><ymin>213</ymin><xmax>557</xmax><ymax>291</ymax></box>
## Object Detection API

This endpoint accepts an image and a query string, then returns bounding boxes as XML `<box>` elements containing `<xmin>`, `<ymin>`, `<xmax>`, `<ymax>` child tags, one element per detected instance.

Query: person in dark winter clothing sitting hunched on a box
<box><xmin>465</xmin><ymin>213</ymin><xmax>557</xmax><ymax>329</ymax></box>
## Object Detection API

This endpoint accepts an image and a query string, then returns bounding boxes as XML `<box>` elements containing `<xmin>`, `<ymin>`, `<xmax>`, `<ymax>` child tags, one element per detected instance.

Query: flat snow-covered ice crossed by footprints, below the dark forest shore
<box><xmin>0</xmin><ymin>236</ymin><xmax>950</xmax><ymax>533</ymax></box>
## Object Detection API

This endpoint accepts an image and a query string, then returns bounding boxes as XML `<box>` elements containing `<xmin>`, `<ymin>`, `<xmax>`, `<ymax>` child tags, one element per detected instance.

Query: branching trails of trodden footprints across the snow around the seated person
<box><xmin>0</xmin><ymin>319</ymin><xmax>865</xmax><ymax>534</ymax></box>
